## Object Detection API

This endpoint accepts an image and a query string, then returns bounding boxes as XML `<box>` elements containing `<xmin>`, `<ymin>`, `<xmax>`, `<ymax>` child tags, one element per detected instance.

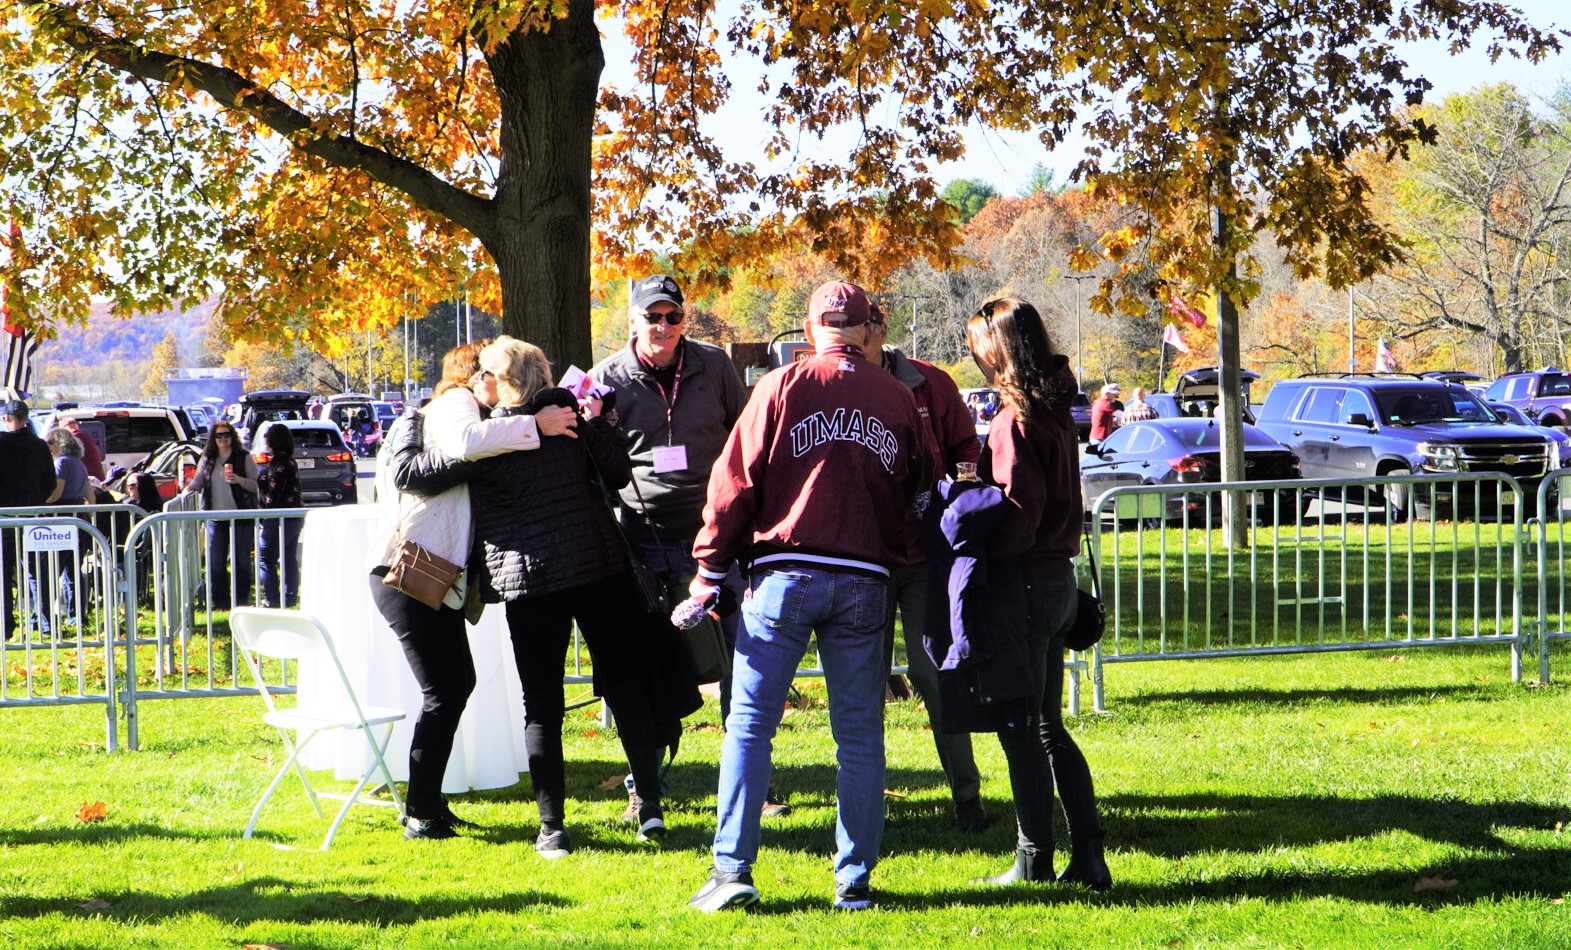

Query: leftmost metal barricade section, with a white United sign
<box><xmin>0</xmin><ymin>506</ymin><xmax>127</xmax><ymax>751</ymax></box>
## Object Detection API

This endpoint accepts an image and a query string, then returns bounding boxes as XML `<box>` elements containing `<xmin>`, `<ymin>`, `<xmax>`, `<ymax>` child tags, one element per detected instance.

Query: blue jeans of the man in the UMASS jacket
<box><xmin>715</xmin><ymin>565</ymin><xmax>889</xmax><ymax>884</ymax></box>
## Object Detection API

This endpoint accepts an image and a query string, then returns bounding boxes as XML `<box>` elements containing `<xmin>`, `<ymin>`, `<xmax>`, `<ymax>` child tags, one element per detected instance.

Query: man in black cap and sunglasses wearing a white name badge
<box><xmin>589</xmin><ymin>273</ymin><xmax>760</xmax><ymax>823</ymax></box>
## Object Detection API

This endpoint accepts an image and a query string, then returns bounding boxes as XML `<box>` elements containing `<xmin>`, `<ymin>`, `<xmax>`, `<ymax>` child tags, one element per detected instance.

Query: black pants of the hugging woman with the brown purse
<box><xmin>371</xmin><ymin>575</ymin><xmax>474</xmax><ymax>820</ymax></box>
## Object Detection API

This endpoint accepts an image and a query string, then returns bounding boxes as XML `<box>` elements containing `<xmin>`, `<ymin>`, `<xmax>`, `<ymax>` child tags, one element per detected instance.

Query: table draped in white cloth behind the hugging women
<box><xmin>297</xmin><ymin>504</ymin><xmax>529</xmax><ymax>793</ymax></box>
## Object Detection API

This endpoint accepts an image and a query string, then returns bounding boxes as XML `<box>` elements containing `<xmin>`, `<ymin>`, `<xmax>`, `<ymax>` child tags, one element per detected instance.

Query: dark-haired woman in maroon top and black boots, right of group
<box><xmin>966</xmin><ymin>297</ymin><xmax>1112</xmax><ymax>890</ymax></box>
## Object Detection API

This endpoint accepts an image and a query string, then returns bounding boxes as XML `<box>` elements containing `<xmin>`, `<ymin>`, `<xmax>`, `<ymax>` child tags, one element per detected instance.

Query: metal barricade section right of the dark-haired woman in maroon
<box><xmin>1092</xmin><ymin>474</ymin><xmax>1535</xmax><ymax>710</ymax></box>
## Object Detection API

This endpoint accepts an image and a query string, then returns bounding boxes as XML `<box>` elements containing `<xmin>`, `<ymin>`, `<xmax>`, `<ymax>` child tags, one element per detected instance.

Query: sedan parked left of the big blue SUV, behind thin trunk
<box><xmin>1081</xmin><ymin>419</ymin><xmax>1304</xmax><ymax>523</ymax></box>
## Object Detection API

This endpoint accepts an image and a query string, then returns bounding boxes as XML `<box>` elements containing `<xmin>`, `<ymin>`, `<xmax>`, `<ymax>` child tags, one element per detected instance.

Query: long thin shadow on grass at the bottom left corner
<box><xmin>0</xmin><ymin>878</ymin><xmax>572</xmax><ymax>926</ymax></box>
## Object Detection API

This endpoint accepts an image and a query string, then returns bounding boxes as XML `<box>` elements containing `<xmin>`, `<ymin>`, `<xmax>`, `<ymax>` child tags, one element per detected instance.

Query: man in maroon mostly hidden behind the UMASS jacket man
<box><xmin>872</xmin><ymin>306</ymin><xmax>988</xmax><ymax>834</ymax></box>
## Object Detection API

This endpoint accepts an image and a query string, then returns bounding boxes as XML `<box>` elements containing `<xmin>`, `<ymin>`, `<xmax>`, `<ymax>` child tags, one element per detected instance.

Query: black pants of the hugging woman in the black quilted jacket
<box><xmin>507</xmin><ymin>575</ymin><xmax>665</xmax><ymax>828</ymax></box>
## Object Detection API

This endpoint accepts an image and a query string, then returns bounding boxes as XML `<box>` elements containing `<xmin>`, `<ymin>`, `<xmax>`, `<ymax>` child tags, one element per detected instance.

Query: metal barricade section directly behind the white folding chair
<box><xmin>123</xmin><ymin>496</ymin><xmax>308</xmax><ymax>749</ymax></box>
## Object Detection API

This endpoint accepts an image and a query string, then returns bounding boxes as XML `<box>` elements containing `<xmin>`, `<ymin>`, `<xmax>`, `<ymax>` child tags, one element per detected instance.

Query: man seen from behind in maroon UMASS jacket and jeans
<box><xmin>690</xmin><ymin>281</ymin><xmax>933</xmax><ymax>911</ymax></box>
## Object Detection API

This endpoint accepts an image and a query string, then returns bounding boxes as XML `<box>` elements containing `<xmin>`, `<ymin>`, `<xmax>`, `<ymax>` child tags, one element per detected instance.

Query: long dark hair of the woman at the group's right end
<box><xmin>966</xmin><ymin>297</ymin><xmax>1075</xmax><ymax>421</ymax></box>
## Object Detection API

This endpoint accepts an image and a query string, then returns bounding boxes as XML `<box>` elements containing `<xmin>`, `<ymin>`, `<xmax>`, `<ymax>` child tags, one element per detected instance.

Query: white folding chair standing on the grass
<box><xmin>229</xmin><ymin>608</ymin><xmax>404</xmax><ymax>851</ymax></box>
